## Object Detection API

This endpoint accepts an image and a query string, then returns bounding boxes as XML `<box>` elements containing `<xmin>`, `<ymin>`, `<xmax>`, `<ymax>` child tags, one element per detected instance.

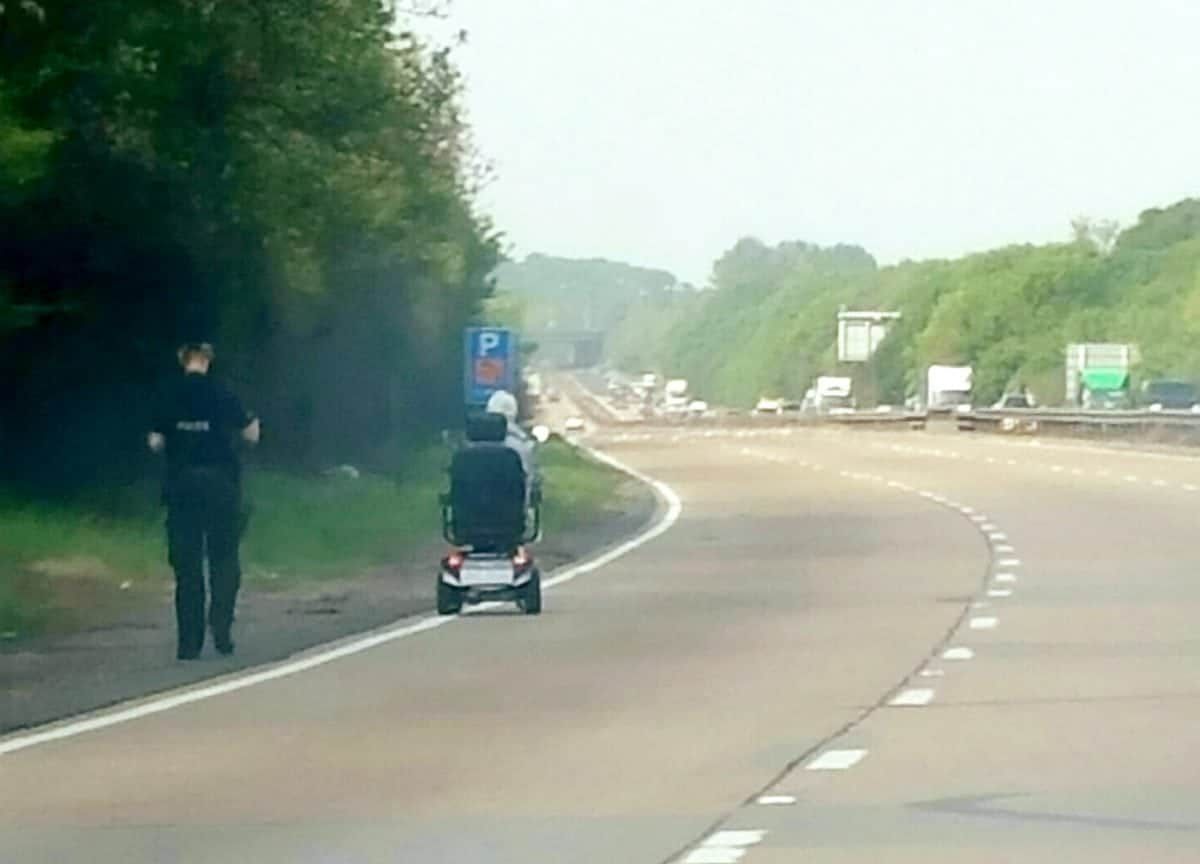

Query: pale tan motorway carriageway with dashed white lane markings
<box><xmin>0</xmin><ymin>428</ymin><xmax>1200</xmax><ymax>864</ymax></box>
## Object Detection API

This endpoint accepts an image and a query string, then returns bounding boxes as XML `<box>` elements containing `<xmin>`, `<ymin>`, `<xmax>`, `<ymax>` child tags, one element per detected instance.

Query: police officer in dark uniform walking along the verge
<box><xmin>148</xmin><ymin>342</ymin><xmax>260</xmax><ymax>660</ymax></box>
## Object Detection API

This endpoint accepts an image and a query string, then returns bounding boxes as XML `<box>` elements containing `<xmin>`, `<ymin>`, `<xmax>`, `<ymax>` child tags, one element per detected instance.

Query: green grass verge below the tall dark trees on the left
<box><xmin>0</xmin><ymin>439</ymin><xmax>624</xmax><ymax>638</ymax></box>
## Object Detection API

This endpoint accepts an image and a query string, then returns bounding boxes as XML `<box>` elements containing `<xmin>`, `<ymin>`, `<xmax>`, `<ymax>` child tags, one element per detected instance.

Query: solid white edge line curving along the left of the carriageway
<box><xmin>0</xmin><ymin>445</ymin><xmax>683</xmax><ymax>756</ymax></box>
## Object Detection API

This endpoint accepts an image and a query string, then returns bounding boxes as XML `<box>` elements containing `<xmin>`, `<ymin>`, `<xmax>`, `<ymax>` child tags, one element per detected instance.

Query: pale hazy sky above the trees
<box><xmin>417</xmin><ymin>0</ymin><xmax>1200</xmax><ymax>281</ymax></box>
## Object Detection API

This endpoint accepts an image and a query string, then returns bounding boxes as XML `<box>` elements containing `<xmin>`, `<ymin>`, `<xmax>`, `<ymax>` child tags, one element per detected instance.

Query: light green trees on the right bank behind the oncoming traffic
<box><xmin>610</xmin><ymin>199</ymin><xmax>1200</xmax><ymax>406</ymax></box>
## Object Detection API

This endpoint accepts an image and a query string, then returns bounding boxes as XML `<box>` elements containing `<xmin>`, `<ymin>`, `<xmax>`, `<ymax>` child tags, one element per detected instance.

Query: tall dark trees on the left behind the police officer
<box><xmin>0</xmin><ymin>0</ymin><xmax>499</xmax><ymax>493</ymax></box>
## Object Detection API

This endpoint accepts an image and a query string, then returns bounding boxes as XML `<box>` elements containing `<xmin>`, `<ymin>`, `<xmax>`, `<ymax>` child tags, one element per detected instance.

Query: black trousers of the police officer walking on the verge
<box><xmin>167</xmin><ymin>468</ymin><xmax>241</xmax><ymax>654</ymax></box>
